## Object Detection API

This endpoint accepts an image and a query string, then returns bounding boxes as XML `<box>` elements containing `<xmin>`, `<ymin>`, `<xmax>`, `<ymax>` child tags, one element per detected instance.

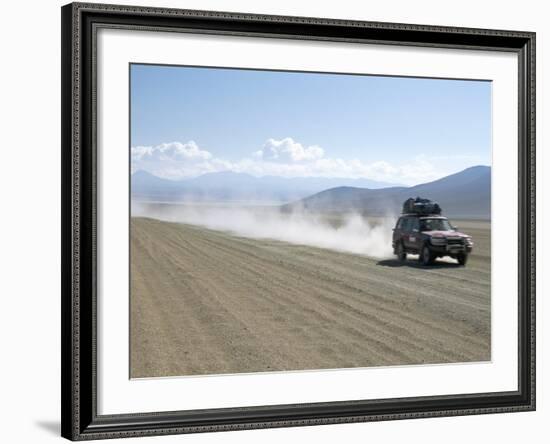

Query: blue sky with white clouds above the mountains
<box><xmin>131</xmin><ymin>64</ymin><xmax>491</xmax><ymax>185</ymax></box>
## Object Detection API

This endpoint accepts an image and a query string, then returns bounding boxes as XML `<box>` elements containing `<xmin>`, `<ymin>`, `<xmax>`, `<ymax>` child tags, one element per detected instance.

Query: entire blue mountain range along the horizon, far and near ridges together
<box><xmin>131</xmin><ymin>166</ymin><xmax>491</xmax><ymax>219</ymax></box>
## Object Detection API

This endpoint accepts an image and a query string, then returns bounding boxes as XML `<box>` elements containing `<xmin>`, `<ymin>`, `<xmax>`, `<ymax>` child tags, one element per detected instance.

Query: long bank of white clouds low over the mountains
<box><xmin>131</xmin><ymin>137</ymin><xmax>464</xmax><ymax>185</ymax></box>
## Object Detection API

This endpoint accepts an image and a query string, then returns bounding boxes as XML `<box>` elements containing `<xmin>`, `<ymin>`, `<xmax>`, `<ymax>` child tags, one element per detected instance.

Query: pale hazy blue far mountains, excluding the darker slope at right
<box><xmin>131</xmin><ymin>171</ymin><xmax>404</xmax><ymax>204</ymax></box>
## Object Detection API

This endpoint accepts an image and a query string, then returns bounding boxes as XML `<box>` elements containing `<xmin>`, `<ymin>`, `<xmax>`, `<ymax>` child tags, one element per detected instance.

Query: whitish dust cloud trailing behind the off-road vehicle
<box><xmin>131</xmin><ymin>202</ymin><xmax>396</xmax><ymax>258</ymax></box>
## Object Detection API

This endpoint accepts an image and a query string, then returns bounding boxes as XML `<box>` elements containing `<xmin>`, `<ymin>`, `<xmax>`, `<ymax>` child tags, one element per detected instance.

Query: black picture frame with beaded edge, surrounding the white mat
<box><xmin>61</xmin><ymin>3</ymin><xmax>535</xmax><ymax>440</ymax></box>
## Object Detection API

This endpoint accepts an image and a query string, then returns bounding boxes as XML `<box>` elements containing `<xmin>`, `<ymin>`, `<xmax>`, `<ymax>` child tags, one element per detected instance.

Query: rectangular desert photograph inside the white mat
<box><xmin>130</xmin><ymin>63</ymin><xmax>496</xmax><ymax>379</ymax></box>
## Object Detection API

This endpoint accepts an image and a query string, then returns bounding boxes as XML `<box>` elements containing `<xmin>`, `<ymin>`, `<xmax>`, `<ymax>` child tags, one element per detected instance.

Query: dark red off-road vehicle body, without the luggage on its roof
<box><xmin>392</xmin><ymin>199</ymin><xmax>474</xmax><ymax>265</ymax></box>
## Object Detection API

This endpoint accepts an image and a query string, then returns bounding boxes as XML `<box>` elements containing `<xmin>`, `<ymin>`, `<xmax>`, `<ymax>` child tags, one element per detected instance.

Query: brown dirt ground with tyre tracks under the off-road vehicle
<box><xmin>130</xmin><ymin>218</ymin><xmax>490</xmax><ymax>378</ymax></box>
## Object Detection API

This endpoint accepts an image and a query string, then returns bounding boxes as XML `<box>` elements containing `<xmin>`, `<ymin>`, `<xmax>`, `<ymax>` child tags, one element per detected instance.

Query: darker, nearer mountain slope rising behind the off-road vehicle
<box><xmin>282</xmin><ymin>166</ymin><xmax>491</xmax><ymax>219</ymax></box>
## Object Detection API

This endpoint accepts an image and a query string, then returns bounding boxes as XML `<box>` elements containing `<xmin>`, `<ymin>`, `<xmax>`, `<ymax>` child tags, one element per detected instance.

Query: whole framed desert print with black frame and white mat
<box><xmin>62</xmin><ymin>3</ymin><xmax>535</xmax><ymax>440</ymax></box>
